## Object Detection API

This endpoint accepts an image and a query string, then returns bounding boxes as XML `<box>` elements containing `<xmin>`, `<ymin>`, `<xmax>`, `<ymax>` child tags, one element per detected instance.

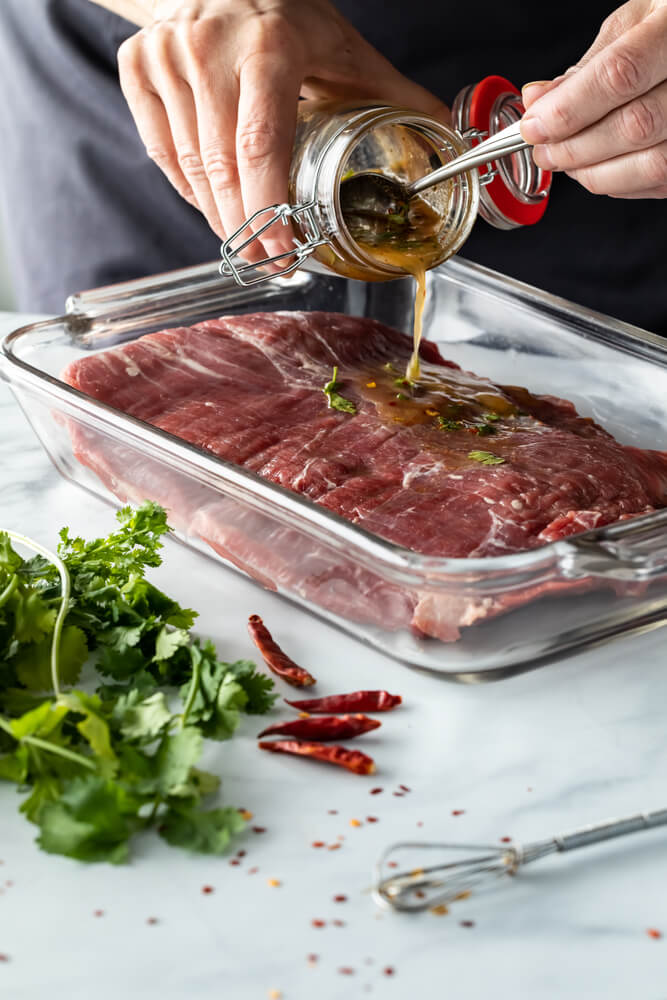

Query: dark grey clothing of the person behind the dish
<box><xmin>0</xmin><ymin>0</ymin><xmax>667</xmax><ymax>334</ymax></box>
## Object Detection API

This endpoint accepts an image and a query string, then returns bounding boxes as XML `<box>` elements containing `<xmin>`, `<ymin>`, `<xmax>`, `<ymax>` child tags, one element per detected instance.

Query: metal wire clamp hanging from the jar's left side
<box><xmin>220</xmin><ymin>201</ymin><xmax>328</xmax><ymax>286</ymax></box>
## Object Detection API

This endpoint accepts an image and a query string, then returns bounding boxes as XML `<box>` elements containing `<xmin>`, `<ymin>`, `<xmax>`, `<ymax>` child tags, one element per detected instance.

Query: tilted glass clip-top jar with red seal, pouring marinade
<box><xmin>220</xmin><ymin>76</ymin><xmax>551</xmax><ymax>285</ymax></box>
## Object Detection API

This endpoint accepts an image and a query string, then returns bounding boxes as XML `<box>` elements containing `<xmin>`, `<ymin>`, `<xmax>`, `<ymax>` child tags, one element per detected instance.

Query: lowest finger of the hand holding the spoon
<box><xmin>566</xmin><ymin>142</ymin><xmax>667</xmax><ymax>198</ymax></box>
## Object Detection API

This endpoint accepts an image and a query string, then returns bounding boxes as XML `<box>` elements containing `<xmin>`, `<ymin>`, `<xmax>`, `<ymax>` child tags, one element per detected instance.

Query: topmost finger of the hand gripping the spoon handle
<box><xmin>521</xmin><ymin>7</ymin><xmax>667</xmax><ymax>145</ymax></box>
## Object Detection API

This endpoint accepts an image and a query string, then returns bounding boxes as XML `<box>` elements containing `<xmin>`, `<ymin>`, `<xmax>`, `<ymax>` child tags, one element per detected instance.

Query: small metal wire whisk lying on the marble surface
<box><xmin>373</xmin><ymin>809</ymin><xmax>667</xmax><ymax>913</ymax></box>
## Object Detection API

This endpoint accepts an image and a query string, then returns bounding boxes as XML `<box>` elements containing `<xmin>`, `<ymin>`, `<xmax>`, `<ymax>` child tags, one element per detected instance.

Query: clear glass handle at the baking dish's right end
<box><xmin>557</xmin><ymin>510</ymin><xmax>667</xmax><ymax>582</ymax></box>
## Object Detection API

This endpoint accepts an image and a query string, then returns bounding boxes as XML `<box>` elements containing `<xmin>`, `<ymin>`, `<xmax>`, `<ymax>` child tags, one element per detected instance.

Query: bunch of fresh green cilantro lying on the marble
<box><xmin>0</xmin><ymin>502</ymin><xmax>276</xmax><ymax>863</ymax></box>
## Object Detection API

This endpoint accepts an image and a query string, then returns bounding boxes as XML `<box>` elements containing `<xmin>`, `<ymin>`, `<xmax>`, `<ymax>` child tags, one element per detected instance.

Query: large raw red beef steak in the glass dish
<box><xmin>64</xmin><ymin>312</ymin><xmax>667</xmax><ymax>639</ymax></box>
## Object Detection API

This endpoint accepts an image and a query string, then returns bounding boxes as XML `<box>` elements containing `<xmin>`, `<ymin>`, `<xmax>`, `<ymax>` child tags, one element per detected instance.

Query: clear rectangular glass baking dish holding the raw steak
<box><xmin>0</xmin><ymin>259</ymin><xmax>667</xmax><ymax>681</ymax></box>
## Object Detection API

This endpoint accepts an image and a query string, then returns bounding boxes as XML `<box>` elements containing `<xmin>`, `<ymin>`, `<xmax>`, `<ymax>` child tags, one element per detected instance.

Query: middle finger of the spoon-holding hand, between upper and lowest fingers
<box><xmin>533</xmin><ymin>81</ymin><xmax>667</xmax><ymax>171</ymax></box>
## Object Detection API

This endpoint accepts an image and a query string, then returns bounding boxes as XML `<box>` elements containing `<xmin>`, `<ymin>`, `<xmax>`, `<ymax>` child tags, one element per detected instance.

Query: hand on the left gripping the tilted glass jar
<box><xmin>118</xmin><ymin>0</ymin><xmax>449</xmax><ymax>260</ymax></box>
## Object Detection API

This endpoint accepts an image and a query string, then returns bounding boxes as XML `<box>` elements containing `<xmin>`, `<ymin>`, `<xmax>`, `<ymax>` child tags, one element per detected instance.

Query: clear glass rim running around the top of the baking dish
<box><xmin>0</xmin><ymin>259</ymin><xmax>667</xmax><ymax>591</ymax></box>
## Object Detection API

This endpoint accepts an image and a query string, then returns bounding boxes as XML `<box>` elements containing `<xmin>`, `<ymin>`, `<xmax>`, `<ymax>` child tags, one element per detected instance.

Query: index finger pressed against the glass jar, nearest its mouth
<box><xmin>236</xmin><ymin>53</ymin><xmax>301</xmax><ymax>266</ymax></box>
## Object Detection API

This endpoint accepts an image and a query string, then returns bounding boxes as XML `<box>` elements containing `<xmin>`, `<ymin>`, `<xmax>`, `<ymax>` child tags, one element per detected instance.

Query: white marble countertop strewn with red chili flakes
<box><xmin>0</xmin><ymin>306</ymin><xmax>667</xmax><ymax>1000</ymax></box>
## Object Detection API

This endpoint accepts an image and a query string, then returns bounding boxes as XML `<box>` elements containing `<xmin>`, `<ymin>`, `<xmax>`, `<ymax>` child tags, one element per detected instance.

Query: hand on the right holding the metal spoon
<box><xmin>521</xmin><ymin>0</ymin><xmax>667</xmax><ymax>198</ymax></box>
